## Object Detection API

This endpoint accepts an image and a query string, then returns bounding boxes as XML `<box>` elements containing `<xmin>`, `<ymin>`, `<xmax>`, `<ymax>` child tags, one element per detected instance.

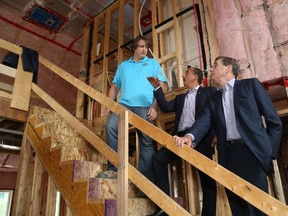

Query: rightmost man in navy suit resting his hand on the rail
<box><xmin>175</xmin><ymin>56</ymin><xmax>282</xmax><ymax>216</ymax></box>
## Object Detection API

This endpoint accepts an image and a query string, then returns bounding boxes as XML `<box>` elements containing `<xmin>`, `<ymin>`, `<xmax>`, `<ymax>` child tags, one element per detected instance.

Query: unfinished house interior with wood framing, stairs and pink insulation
<box><xmin>0</xmin><ymin>0</ymin><xmax>288</xmax><ymax>216</ymax></box>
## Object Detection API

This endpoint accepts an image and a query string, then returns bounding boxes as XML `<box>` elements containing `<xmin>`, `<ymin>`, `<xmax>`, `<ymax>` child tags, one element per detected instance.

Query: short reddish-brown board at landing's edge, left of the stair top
<box><xmin>0</xmin><ymin>99</ymin><xmax>28</xmax><ymax>123</ymax></box>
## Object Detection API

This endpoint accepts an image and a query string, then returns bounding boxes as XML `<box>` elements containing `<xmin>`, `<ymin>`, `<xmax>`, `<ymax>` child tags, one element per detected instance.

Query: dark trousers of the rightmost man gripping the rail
<box><xmin>226</xmin><ymin>143</ymin><xmax>268</xmax><ymax>216</ymax></box>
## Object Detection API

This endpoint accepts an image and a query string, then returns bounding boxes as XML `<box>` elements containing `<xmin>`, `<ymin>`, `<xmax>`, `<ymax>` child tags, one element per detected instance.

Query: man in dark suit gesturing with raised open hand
<box><xmin>148</xmin><ymin>66</ymin><xmax>216</xmax><ymax>216</ymax></box>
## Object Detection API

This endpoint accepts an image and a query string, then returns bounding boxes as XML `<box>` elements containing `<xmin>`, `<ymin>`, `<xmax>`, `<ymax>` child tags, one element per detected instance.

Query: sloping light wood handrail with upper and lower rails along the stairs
<box><xmin>0</xmin><ymin>39</ymin><xmax>288</xmax><ymax>216</ymax></box>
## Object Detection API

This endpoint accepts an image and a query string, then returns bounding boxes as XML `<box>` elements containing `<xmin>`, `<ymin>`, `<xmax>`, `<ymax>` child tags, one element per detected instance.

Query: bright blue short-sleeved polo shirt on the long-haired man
<box><xmin>112</xmin><ymin>56</ymin><xmax>166</xmax><ymax>107</ymax></box>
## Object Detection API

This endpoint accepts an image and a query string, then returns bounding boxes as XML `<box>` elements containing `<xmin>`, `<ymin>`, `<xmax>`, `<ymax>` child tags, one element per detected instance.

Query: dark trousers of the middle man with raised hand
<box><xmin>153</xmin><ymin>143</ymin><xmax>217</xmax><ymax>216</ymax></box>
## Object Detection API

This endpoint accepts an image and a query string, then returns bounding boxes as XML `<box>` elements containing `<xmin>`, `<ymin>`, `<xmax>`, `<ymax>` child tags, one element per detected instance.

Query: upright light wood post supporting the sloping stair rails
<box><xmin>117</xmin><ymin>111</ymin><xmax>129</xmax><ymax>216</ymax></box>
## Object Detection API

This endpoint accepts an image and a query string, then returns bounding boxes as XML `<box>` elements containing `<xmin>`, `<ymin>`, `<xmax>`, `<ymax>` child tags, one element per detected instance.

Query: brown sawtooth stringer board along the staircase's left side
<box><xmin>27</xmin><ymin>115</ymin><xmax>105</xmax><ymax>216</ymax></box>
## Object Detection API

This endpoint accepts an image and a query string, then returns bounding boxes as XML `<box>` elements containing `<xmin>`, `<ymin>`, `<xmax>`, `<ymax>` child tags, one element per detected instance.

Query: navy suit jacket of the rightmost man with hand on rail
<box><xmin>189</xmin><ymin>78</ymin><xmax>282</xmax><ymax>172</ymax></box>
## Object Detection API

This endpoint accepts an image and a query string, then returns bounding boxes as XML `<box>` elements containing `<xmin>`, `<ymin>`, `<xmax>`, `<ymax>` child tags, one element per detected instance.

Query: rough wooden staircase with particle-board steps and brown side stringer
<box><xmin>27</xmin><ymin>107</ymin><xmax>155</xmax><ymax>216</ymax></box>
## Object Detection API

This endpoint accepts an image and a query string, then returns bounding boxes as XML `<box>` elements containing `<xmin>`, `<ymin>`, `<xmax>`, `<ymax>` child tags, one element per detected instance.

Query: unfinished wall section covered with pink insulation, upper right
<box><xmin>212</xmin><ymin>0</ymin><xmax>288</xmax><ymax>81</ymax></box>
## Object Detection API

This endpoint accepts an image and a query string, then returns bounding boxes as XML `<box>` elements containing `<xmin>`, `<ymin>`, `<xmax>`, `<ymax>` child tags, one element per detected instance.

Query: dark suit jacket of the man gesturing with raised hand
<box><xmin>154</xmin><ymin>86</ymin><xmax>216</xmax><ymax>158</ymax></box>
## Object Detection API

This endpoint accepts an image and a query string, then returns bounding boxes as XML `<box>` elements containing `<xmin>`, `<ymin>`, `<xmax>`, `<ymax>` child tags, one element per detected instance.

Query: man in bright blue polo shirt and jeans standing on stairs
<box><xmin>98</xmin><ymin>36</ymin><xmax>166</xmax><ymax>181</ymax></box>
